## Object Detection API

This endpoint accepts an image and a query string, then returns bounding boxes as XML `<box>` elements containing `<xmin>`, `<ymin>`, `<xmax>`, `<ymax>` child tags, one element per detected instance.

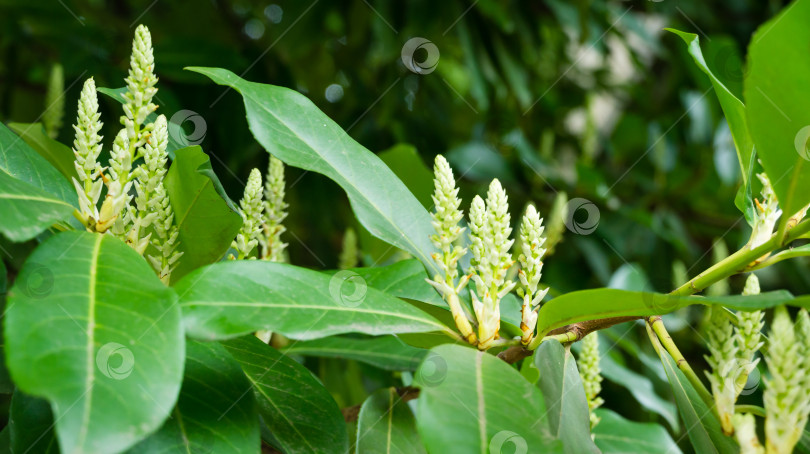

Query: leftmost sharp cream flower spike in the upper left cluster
<box><xmin>73</xmin><ymin>77</ymin><xmax>103</xmax><ymax>232</ymax></box>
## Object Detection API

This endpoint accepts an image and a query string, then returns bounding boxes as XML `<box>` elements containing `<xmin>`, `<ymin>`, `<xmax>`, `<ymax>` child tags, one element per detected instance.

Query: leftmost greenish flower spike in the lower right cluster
<box><xmin>705</xmin><ymin>306</ymin><xmax>738</xmax><ymax>435</ymax></box>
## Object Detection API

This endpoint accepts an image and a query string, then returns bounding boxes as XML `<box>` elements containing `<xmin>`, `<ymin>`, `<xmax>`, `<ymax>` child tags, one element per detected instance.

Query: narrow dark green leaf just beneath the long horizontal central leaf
<box><xmin>282</xmin><ymin>336</ymin><xmax>427</xmax><ymax>371</ymax></box>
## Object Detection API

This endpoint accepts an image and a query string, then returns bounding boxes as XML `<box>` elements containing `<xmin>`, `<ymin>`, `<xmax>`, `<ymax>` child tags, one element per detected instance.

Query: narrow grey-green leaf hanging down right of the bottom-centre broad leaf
<box><xmin>534</xmin><ymin>340</ymin><xmax>599</xmax><ymax>454</ymax></box>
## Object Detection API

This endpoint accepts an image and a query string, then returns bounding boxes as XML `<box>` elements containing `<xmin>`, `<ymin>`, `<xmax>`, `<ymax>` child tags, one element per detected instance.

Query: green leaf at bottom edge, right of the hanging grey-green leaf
<box><xmin>593</xmin><ymin>408</ymin><xmax>681</xmax><ymax>454</ymax></box>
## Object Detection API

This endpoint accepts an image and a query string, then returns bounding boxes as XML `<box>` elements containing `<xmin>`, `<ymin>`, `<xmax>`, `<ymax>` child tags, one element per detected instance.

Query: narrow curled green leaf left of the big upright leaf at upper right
<box><xmin>665</xmin><ymin>28</ymin><xmax>759</xmax><ymax>184</ymax></box>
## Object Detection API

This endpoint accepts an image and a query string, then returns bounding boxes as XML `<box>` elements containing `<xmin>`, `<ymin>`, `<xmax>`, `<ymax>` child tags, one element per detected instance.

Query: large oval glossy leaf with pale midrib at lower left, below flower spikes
<box><xmin>4</xmin><ymin>232</ymin><xmax>185</xmax><ymax>452</ymax></box>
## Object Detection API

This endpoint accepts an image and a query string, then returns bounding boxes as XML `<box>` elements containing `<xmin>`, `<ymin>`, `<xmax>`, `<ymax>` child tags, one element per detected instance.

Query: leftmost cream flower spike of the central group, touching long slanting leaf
<box><xmin>427</xmin><ymin>155</ymin><xmax>477</xmax><ymax>344</ymax></box>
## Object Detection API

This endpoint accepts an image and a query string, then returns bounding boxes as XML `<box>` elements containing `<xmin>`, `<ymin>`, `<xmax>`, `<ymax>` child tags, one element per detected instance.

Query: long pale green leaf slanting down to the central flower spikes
<box><xmin>187</xmin><ymin>67</ymin><xmax>437</xmax><ymax>274</ymax></box>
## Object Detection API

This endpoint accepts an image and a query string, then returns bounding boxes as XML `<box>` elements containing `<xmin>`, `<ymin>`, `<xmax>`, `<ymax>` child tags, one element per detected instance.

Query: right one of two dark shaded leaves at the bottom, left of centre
<box><xmin>223</xmin><ymin>336</ymin><xmax>349</xmax><ymax>454</ymax></box>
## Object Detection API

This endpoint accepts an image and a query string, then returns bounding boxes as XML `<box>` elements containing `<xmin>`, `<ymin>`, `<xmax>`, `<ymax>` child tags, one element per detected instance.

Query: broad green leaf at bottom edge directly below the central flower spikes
<box><xmin>414</xmin><ymin>345</ymin><xmax>562</xmax><ymax>454</ymax></box>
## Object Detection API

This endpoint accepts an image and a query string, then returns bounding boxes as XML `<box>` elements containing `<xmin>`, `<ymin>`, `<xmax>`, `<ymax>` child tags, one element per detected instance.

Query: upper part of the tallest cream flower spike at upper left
<box><xmin>121</xmin><ymin>25</ymin><xmax>157</xmax><ymax>142</ymax></box>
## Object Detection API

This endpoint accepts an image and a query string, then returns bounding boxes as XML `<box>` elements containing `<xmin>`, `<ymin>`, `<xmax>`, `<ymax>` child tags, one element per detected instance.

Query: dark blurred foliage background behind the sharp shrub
<box><xmin>0</xmin><ymin>0</ymin><xmax>796</xmax><ymax>446</ymax></box>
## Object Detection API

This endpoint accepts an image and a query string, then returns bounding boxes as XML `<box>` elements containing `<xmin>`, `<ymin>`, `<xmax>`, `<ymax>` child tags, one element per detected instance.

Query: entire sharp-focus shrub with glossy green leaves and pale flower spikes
<box><xmin>0</xmin><ymin>2</ymin><xmax>810</xmax><ymax>453</ymax></box>
